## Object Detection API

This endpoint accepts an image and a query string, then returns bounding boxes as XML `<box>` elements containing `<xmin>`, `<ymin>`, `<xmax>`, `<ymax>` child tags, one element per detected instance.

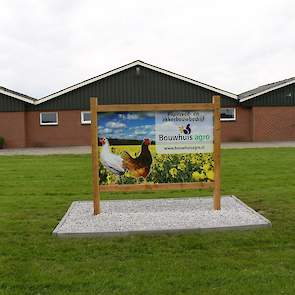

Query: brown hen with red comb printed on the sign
<box><xmin>122</xmin><ymin>138</ymin><xmax>153</xmax><ymax>182</ymax></box>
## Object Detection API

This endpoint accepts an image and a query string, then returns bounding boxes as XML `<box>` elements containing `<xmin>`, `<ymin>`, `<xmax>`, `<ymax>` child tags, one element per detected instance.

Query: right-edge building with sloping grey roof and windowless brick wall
<box><xmin>238</xmin><ymin>77</ymin><xmax>295</xmax><ymax>141</ymax></box>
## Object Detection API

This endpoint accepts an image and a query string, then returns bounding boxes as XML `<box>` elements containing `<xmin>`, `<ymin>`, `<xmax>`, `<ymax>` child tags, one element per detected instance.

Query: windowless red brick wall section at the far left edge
<box><xmin>0</xmin><ymin>112</ymin><xmax>26</xmax><ymax>148</ymax></box>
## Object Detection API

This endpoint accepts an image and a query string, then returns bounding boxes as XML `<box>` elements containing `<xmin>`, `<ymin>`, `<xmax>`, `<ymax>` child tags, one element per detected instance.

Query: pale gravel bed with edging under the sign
<box><xmin>53</xmin><ymin>196</ymin><xmax>271</xmax><ymax>236</ymax></box>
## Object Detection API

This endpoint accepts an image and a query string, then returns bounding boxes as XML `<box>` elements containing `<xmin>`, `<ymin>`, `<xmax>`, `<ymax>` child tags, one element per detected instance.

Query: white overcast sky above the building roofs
<box><xmin>0</xmin><ymin>0</ymin><xmax>295</xmax><ymax>98</ymax></box>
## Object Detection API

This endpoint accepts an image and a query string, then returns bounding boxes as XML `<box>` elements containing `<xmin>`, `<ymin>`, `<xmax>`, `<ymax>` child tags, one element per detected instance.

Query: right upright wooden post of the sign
<box><xmin>213</xmin><ymin>95</ymin><xmax>221</xmax><ymax>210</ymax></box>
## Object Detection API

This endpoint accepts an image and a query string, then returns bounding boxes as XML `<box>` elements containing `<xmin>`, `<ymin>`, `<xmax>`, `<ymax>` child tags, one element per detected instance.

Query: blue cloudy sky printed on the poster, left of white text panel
<box><xmin>98</xmin><ymin>112</ymin><xmax>155</xmax><ymax>140</ymax></box>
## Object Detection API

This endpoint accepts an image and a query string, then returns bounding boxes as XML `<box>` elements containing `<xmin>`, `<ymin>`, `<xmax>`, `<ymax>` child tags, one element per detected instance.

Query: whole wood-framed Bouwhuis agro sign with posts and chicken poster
<box><xmin>91</xmin><ymin>97</ymin><xmax>220</xmax><ymax>214</ymax></box>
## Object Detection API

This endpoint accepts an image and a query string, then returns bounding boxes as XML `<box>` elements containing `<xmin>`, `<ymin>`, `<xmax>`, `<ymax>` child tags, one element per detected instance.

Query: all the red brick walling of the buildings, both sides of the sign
<box><xmin>0</xmin><ymin>106</ymin><xmax>295</xmax><ymax>148</ymax></box>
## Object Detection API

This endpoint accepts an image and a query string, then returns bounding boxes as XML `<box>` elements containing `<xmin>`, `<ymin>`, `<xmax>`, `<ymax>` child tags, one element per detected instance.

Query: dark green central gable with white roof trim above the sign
<box><xmin>30</xmin><ymin>61</ymin><xmax>238</xmax><ymax>110</ymax></box>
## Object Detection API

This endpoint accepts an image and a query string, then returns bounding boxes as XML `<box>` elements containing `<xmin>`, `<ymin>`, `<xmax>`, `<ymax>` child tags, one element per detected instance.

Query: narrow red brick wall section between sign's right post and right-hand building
<box><xmin>221</xmin><ymin>107</ymin><xmax>252</xmax><ymax>142</ymax></box>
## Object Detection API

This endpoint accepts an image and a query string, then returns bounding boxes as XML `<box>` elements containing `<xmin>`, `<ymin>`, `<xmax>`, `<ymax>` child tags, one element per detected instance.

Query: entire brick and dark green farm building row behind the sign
<box><xmin>0</xmin><ymin>61</ymin><xmax>295</xmax><ymax>148</ymax></box>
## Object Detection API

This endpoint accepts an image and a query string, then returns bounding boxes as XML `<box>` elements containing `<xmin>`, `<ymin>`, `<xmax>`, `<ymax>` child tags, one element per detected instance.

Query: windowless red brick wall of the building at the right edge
<box><xmin>253</xmin><ymin>106</ymin><xmax>295</xmax><ymax>141</ymax></box>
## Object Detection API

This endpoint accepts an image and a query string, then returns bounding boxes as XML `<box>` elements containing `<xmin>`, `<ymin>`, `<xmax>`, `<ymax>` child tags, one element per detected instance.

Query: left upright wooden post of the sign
<box><xmin>90</xmin><ymin>97</ymin><xmax>100</xmax><ymax>215</ymax></box>
